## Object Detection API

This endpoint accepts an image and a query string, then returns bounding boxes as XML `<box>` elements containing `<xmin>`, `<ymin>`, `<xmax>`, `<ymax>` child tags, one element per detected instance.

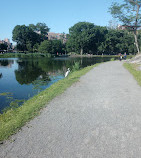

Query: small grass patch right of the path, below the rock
<box><xmin>124</xmin><ymin>63</ymin><xmax>141</xmax><ymax>86</ymax></box>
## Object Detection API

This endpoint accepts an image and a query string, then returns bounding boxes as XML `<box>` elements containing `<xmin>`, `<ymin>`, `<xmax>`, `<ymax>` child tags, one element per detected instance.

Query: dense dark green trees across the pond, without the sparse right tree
<box><xmin>12</xmin><ymin>22</ymin><xmax>141</xmax><ymax>56</ymax></box>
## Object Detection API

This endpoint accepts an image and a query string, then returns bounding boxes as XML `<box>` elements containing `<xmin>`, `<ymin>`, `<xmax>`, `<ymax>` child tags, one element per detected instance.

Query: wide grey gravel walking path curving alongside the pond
<box><xmin>0</xmin><ymin>61</ymin><xmax>141</xmax><ymax>158</ymax></box>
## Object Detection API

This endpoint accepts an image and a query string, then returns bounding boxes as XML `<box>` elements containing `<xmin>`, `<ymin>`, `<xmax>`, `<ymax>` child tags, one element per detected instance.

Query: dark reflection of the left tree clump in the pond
<box><xmin>15</xmin><ymin>58</ymin><xmax>66</xmax><ymax>90</ymax></box>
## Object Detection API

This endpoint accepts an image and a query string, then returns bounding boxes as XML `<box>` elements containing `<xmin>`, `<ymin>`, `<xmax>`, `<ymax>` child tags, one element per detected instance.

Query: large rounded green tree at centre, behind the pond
<box><xmin>66</xmin><ymin>22</ymin><xmax>108</xmax><ymax>55</ymax></box>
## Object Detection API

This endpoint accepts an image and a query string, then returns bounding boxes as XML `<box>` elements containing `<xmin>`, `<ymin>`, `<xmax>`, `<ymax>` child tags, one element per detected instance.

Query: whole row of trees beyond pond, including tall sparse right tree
<box><xmin>10</xmin><ymin>0</ymin><xmax>141</xmax><ymax>55</ymax></box>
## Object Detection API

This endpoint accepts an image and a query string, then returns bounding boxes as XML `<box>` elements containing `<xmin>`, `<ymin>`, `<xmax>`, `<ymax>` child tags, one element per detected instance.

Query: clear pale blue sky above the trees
<box><xmin>0</xmin><ymin>0</ymin><xmax>123</xmax><ymax>42</ymax></box>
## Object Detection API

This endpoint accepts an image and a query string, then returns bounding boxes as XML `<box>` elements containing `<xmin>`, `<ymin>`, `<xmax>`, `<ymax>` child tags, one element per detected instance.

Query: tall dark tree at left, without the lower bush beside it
<box><xmin>12</xmin><ymin>23</ymin><xmax>49</xmax><ymax>52</ymax></box>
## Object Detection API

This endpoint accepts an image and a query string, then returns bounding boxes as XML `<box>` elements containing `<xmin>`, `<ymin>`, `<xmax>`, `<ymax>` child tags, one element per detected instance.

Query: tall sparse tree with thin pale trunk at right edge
<box><xmin>109</xmin><ymin>0</ymin><xmax>141</xmax><ymax>53</ymax></box>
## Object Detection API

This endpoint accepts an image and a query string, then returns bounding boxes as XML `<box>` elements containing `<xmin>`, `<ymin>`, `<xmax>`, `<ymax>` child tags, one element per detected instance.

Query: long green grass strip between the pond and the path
<box><xmin>0</xmin><ymin>64</ymin><xmax>98</xmax><ymax>141</ymax></box>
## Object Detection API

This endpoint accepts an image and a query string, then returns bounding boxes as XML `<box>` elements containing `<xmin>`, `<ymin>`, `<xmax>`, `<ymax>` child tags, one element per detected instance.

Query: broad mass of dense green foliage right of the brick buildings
<box><xmin>66</xmin><ymin>22</ymin><xmax>141</xmax><ymax>55</ymax></box>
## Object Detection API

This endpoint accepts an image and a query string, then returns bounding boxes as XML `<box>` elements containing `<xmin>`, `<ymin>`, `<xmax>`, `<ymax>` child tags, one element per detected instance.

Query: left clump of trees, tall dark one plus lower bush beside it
<box><xmin>12</xmin><ymin>23</ymin><xmax>64</xmax><ymax>55</ymax></box>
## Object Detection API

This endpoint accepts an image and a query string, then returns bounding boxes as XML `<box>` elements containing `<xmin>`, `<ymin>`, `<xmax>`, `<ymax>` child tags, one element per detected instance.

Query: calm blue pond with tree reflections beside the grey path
<box><xmin>0</xmin><ymin>57</ymin><xmax>114</xmax><ymax>113</ymax></box>
